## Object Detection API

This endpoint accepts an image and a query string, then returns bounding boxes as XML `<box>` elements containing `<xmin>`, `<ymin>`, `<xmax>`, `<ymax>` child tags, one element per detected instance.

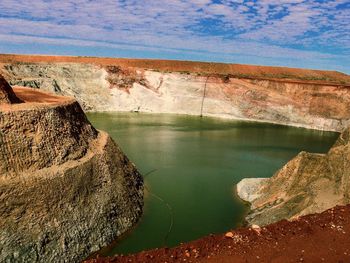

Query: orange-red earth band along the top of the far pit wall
<box><xmin>0</xmin><ymin>54</ymin><xmax>350</xmax><ymax>85</ymax></box>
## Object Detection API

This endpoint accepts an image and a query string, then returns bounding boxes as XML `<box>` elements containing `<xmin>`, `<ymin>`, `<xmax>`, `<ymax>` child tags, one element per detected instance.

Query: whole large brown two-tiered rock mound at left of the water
<box><xmin>0</xmin><ymin>80</ymin><xmax>143</xmax><ymax>262</ymax></box>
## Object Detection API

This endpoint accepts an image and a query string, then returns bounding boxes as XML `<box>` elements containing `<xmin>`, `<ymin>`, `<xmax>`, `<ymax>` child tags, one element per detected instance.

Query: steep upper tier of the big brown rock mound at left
<box><xmin>0</xmin><ymin>100</ymin><xmax>98</xmax><ymax>176</ymax></box>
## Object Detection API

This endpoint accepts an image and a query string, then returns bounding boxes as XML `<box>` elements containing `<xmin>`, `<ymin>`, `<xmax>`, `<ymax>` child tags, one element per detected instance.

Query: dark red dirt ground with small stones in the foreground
<box><xmin>86</xmin><ymin>205</ymin><xmax>350</xmax><ymax>263</ymax></box>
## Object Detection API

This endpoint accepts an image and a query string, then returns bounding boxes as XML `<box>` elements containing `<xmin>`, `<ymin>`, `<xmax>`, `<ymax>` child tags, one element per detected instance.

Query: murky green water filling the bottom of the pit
<box><xmin>88</xmin><ymin>113</ymin><xmax>338</xmax><ymax>255</ymax></box>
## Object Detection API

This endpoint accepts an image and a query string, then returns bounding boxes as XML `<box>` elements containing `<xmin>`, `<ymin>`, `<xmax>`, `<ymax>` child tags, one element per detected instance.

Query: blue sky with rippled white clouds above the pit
<box><xmin>0</xmin><ymin>0</ymin><xmax>350</xmax><ymax>74</ymax></box>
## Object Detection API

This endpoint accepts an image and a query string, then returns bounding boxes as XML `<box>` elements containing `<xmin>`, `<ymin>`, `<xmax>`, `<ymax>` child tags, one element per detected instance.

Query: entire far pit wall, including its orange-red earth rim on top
<box><xmin>0</xmin><ymin>55</ymin><xmax>350</xmax><ymax>131</ymax></box>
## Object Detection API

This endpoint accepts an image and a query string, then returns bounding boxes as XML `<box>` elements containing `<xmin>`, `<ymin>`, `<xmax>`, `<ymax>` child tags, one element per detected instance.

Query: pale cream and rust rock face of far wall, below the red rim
<box><xmin>0</xmin><ymin>62</ymin><xmax>350</xmax><ymax>131</ymax></box>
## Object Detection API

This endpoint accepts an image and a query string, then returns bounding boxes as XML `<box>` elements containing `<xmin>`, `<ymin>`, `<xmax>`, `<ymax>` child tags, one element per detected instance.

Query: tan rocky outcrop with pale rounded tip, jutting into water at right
<box><xmin>237</xmin><ymin>128</ymin><xmax>350</xmax><ymax>225</ymax></box>
